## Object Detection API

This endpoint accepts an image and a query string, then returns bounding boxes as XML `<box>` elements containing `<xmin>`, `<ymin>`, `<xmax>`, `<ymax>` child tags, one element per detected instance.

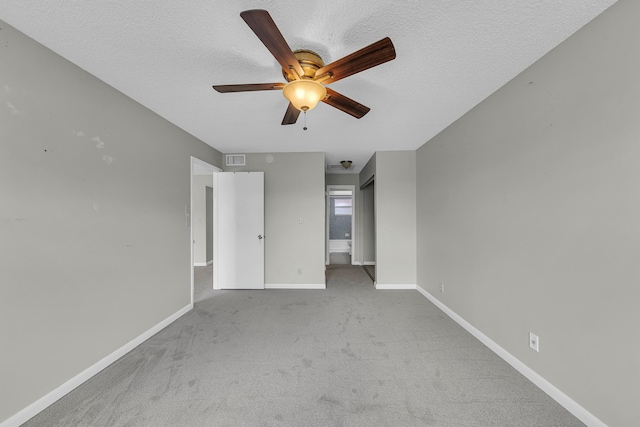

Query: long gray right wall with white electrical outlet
<box><xmin>417</xmin><ymin>0</ymin><xmax>640</xmax><ymax>426</ymax></box>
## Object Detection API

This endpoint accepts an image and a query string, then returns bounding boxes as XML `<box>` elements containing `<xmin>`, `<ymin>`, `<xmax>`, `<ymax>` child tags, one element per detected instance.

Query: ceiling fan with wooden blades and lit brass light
<box><xmin>213</xmin><ymin>9</ymin><xmax>396</xmax><ymax>125</ymax></box>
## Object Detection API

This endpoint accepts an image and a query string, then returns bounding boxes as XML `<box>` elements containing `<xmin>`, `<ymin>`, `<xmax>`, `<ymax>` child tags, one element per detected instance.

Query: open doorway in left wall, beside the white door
<box><xmin>190</xmin><ymin>157</ymin><xmax>220</xmax><ymax>303</ymax></box>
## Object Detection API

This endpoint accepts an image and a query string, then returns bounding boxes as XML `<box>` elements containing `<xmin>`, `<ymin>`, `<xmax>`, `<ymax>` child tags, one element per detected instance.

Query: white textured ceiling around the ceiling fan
<box><xmin>0</xmin><ymin>0</ymin><xmax>615</xmax><ymax>173</ymax></box>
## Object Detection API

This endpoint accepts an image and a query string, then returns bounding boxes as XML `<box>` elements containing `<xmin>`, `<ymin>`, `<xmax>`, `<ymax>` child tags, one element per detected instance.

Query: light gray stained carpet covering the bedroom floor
<box><xmin>26</xmin><ymin>266</ymin><xmax>582</xmax><ymax>427</ymax></box>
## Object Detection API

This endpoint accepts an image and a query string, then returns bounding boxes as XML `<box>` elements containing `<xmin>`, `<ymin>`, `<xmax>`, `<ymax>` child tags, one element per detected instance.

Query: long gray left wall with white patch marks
<box><xmin>0</xmin><ymin>21</ymin><xmax>221</xmax><ymax>422</ymax></box>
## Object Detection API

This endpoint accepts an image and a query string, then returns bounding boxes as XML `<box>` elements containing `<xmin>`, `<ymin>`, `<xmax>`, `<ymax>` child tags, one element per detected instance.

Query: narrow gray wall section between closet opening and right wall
<box><xmin>374</xmin><ymin>151</ymin><xmax>416</xmax><ymax>286</ymax></box>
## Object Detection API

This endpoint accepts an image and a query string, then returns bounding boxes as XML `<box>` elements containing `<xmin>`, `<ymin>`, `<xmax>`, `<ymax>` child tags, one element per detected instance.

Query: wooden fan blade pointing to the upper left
<box><xmin>240</xmin><ymin>9</ymin><xmax>304</xmax><ymax>76</ymax></box>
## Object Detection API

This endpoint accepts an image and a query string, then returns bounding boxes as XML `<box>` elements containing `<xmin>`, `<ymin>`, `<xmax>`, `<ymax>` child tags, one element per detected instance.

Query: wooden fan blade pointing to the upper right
<box><xmin>316</xmin><ymin>37</ymin><xmax>396</xmax><ymax>84</ymax></box>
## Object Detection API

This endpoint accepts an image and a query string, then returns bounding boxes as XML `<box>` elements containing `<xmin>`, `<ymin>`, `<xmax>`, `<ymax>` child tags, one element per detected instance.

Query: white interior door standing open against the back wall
<box><xmin>214</xmin><ymin>172</ymin><xmax>264</xmax><ymax>289</ymax></box>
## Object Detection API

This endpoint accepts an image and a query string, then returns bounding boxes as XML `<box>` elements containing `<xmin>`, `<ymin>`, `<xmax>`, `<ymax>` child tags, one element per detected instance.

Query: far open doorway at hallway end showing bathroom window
<box><xmin>326</xmin><ymin>185</ymin><xmax>356</xmax><ymax>265</ymax></box>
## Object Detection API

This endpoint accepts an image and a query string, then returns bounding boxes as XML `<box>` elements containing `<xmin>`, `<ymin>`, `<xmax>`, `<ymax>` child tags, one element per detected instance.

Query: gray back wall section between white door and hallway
<box><xmin>224</xmin><ymin>153</ymin><xmax>325</xmax><ymax>285</ymax></box>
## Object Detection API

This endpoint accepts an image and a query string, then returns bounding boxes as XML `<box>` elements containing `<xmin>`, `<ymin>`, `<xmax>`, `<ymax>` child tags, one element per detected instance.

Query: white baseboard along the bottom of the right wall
<box><xmin>416</xmin><ymin>286</ymin><xmax>607</xmax><ymax>427</ymax></box>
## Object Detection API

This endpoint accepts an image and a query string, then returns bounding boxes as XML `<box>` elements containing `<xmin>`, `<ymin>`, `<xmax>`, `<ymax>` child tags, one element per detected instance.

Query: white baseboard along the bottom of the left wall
<box><xmin>0</xmin><ymin>304</ymin><xmax>193</xmax><ymax>427</ymax></box>
